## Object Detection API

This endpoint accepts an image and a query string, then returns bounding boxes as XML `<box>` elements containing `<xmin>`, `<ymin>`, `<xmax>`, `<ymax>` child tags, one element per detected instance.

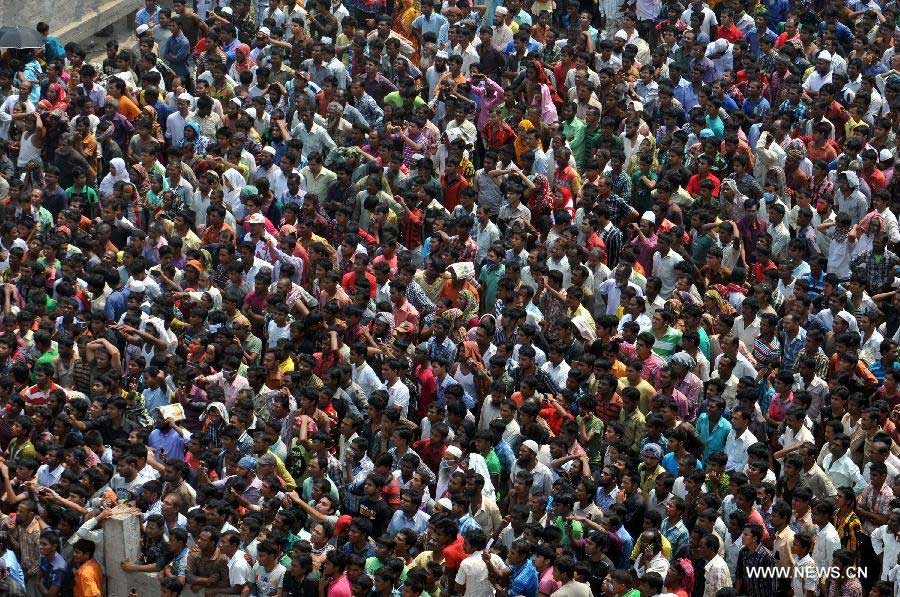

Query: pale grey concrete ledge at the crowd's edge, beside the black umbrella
<box><xmin>0</xmin><ymin>0</ymin><xmax>144</xmax><ymax>45</ymax></box>
